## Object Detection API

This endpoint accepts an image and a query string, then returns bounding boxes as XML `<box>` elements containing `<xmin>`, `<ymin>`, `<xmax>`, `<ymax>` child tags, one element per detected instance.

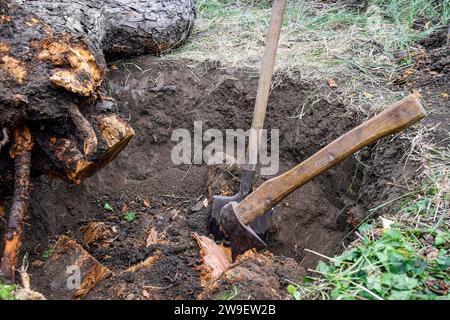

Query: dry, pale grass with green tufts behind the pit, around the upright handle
<box><xmin>167</xmin><ymin>0</ymin><xmax>450</xmax><ymax>116</ymax></box>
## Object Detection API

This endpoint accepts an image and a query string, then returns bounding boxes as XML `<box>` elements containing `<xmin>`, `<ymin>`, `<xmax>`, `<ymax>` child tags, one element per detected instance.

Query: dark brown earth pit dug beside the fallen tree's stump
<box><xmin>11</xmin><ymin>57</ymin><xmax>413</xmax><ymax>299</ymax></box>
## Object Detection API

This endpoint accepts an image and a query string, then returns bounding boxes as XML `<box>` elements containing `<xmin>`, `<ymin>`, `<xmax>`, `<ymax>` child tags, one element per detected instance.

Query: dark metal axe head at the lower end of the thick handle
<box><xmin>220</xmin><ymin>201</ymin><xmax>267</xmax><ymax>260</ymax></box>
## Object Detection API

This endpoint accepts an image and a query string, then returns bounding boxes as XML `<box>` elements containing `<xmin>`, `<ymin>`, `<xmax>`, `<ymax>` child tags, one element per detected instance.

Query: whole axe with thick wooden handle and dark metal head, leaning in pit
<box><xmin>213</xmin><ymin>95</ymin><xmax>426</xmax><ymax>259</ymax></box>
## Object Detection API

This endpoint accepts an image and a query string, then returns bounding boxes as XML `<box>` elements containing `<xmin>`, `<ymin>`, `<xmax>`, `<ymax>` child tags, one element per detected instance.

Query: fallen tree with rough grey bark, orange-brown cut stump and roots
<box><xmin>0</xmin><ymin>0</ymin><xmax>195</xmax><ymax>274</ymax></box>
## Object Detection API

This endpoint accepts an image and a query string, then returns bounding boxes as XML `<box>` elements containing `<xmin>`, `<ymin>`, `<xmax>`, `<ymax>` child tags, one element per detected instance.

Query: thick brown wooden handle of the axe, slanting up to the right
<box><xmin>235</xmin><ymin>95</ymin><xmax>426</xmax><ymax>224</ymax></box>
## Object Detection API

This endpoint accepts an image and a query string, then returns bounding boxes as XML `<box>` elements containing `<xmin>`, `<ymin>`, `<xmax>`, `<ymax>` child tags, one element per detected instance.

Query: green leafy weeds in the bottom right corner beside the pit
<box><xmin>288</xmin><ymin>225</ymin><xmax>450</xmax><ymax>300</ymax></box>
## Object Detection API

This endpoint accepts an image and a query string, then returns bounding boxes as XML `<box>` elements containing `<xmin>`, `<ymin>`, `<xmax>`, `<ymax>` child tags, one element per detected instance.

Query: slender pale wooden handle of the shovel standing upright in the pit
<box><xmin>246</xmin><ymin>0</ymin><xmax>287</xmax><ymax>171</ymax></box>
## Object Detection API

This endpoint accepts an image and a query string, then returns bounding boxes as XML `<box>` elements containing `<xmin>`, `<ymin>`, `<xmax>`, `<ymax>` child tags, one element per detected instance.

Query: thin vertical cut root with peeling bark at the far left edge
<box><xmin>1</xmin><ymin>127</ymin><xmax>33</xmax><ymax>281</ymax></box>
